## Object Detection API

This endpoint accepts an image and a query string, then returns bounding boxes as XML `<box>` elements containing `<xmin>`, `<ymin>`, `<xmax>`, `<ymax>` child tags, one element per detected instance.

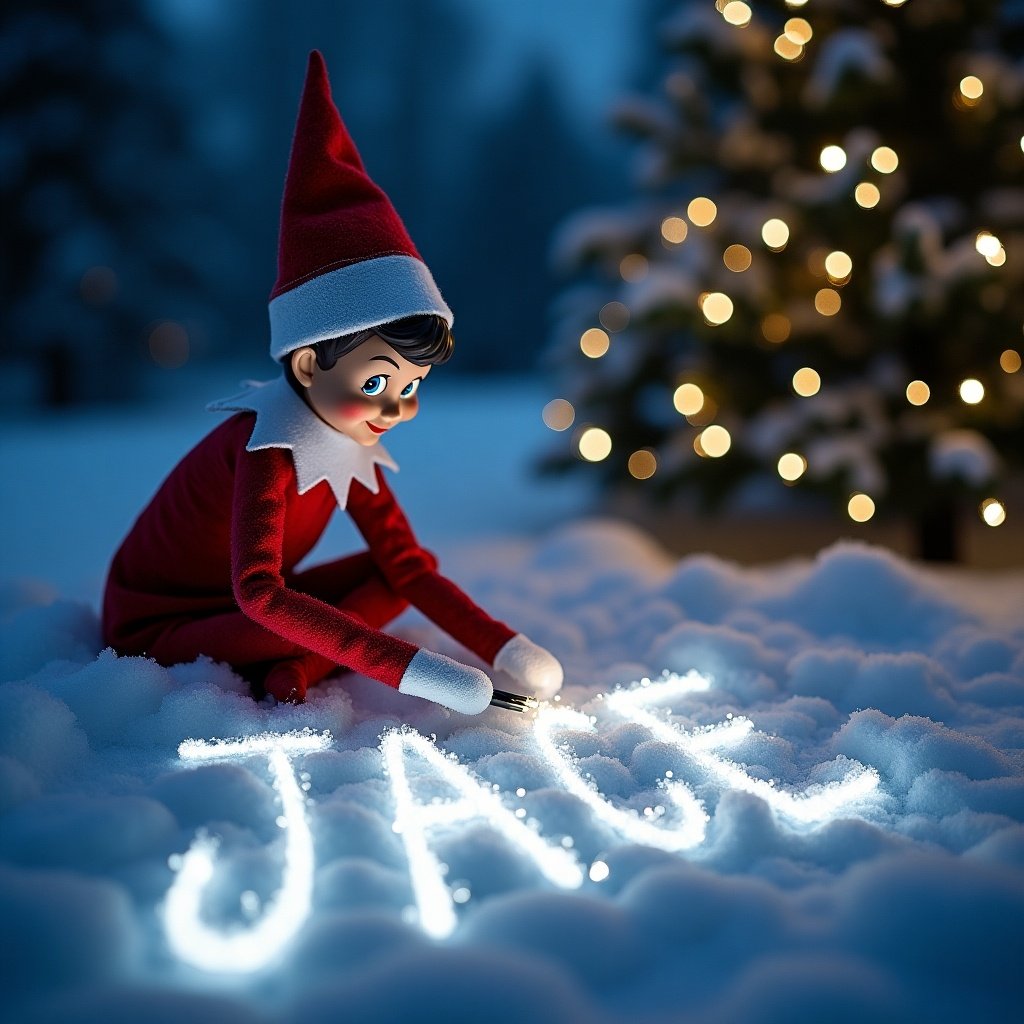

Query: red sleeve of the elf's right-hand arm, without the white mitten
<box><xmin>348</xmin><ymin>469</ymin><xmax>515</xmax><ymax>665</ymax></box>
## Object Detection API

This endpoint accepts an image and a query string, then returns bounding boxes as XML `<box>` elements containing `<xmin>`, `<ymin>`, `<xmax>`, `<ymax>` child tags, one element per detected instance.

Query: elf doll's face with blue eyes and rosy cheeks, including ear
<box><xmin>292</xmin><ymin>335</ymin><xmax>430</xmax><ymax>445</ymax></box>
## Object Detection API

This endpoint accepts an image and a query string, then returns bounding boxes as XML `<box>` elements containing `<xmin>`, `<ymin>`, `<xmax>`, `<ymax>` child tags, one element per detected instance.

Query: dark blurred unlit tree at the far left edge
<box><xmin>0</xmin><ymin>0</ymin><xmax>223</xmax><ymax>404</ymax></box>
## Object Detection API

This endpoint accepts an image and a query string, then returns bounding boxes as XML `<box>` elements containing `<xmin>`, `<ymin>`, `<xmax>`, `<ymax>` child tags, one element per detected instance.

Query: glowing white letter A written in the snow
<box><xmin>381</xmin><ymin>730</ymin><xmax>584</xmax><ymax>939</ymax></box>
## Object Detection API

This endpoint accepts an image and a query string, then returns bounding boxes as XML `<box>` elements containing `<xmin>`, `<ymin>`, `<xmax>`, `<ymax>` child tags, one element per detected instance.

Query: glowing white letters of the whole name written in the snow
<box><xmin>165</xmin><ymin>672</ymin><xmax>879</xmax><ymax>972</ymax></box>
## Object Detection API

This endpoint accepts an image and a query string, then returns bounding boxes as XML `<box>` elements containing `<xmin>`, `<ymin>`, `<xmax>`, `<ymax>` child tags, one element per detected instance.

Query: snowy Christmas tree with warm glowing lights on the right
<box><xmin>545</xmin><ymin>0</ymin><xmax>1024</xmax><ymax>558</ymax></box>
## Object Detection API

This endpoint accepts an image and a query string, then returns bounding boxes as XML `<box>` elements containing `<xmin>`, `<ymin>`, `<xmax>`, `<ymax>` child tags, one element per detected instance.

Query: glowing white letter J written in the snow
<box><xmin>164</xmin><ymin>729</ymin><xmax>332</xmax><ymax>974</ymax></box>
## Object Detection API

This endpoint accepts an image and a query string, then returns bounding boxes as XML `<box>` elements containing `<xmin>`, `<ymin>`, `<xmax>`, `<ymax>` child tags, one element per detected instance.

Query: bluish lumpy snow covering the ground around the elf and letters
<box><xmin>0</xmin><ymin>378</ymin><xmax>1024</xmax><ymax>1024</ymax></box>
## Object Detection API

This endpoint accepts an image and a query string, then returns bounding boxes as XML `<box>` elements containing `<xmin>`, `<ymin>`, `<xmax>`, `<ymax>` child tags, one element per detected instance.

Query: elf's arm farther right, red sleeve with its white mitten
<box><xmin>348</xmin><ymin>468</ymin><xmax>562</xmax><ymax>698</ymax></box>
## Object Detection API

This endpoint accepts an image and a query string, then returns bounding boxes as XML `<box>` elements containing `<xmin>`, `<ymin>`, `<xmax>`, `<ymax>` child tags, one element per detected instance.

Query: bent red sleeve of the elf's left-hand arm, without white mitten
<box><xmin>231</xmin><ymin>449</ymin><xmax>419</xmax><ymax>686</ymax></box>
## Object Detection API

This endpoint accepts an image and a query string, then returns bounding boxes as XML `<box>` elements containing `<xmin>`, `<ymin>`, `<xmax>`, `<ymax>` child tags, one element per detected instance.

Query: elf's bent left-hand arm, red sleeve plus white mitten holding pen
<box><xmin>231</xmin><ymin>449</ymin><xmax>492</xmax><ymax>714</ymax></box>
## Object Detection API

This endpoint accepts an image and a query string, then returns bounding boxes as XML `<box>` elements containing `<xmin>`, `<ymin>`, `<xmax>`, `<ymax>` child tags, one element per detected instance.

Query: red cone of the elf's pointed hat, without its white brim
<box><xmin>270</xmin><ymin>50</ymin><xmax>421</xmax><ymax>299</ymax></box>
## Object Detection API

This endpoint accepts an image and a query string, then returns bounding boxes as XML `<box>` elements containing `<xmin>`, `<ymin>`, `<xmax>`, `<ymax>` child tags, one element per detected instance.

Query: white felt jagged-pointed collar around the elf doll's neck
<box><xmin>206</xmin><ymin>377</ymin><xmax>398</xmax><ymax>509</ymax></box>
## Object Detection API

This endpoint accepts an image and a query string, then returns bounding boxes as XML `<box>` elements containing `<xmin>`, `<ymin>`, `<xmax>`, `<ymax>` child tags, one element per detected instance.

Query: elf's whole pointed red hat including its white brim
<box><xmin>270</xmin><ymin>50</ymin><xmax>454</xmax><ymax>359</ymax></box>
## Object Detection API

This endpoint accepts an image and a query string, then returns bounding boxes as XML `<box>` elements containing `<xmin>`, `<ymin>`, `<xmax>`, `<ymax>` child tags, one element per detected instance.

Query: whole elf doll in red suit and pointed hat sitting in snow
<box><xmin>103</xmin><ymin>51</ymin><xmax>562</xmax><ymax>714</ymax></box>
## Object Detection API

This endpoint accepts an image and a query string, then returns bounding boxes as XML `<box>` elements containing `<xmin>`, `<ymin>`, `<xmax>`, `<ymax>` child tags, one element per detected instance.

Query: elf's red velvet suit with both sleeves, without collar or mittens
<box><xmin>102</xmin><ymin>413</ymin><xmax>514</xmax><ymax>686</ymax></box>
